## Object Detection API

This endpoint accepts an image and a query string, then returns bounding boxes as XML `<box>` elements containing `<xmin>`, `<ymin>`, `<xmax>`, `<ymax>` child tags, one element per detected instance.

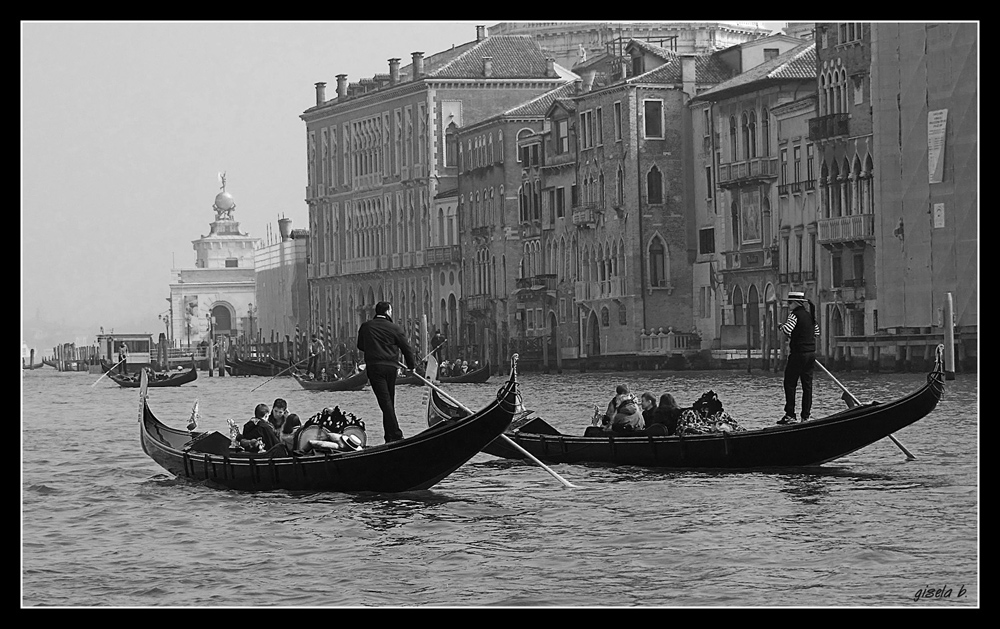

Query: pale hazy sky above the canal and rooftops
<box><xmin>21</xmin><ymin>19</ymin><xmax>782</xmax><ymax>354</ymax></box>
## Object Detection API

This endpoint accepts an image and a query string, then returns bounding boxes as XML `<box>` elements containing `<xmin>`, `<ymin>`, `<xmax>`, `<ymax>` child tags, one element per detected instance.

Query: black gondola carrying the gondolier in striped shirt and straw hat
<box><xmin>428</xmin><ymin>351</ymin><xmax>944</xmax><ymax>469</ymax></box>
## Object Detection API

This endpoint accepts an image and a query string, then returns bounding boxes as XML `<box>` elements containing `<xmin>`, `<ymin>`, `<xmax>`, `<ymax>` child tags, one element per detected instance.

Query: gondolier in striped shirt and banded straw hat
<box><xmin>778</xmin><ymin>291</ymin><xmax>819</xmax><ymax>424</ymax></box>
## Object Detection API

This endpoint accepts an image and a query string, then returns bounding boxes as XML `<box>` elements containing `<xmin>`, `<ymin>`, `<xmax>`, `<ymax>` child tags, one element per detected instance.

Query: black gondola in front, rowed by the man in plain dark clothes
<box><xmin>139</xmin><ymin>356</ymin><xmax>518</xmax><ymax>493</ymax></box>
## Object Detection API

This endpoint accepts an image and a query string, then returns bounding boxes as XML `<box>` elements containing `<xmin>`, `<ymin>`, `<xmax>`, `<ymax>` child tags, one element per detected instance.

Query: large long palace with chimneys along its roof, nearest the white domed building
<box><xmin>300</xmin><ymin>27</ymin><xmax>575</xmax><ymax>356</ymax></box>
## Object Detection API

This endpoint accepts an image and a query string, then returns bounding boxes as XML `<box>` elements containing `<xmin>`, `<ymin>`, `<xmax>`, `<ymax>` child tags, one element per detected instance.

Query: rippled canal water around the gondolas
<box><xmin>21</xmin><ymin>368</ymin><xmax>980</xmax><ymax>607</ymax></box>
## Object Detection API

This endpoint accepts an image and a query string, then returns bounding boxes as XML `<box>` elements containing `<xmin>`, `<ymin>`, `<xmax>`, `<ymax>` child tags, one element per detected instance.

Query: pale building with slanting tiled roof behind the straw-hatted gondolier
<box><xmin>691</xmin><ymin>35</ymin><xmax>816</xmax><ymax>349</ymax></box>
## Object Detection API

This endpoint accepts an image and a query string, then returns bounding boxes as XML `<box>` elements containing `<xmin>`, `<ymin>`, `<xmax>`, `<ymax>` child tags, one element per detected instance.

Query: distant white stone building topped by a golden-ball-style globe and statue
<box><xmin>168</xmin><ymin>177</ymin><xmax>260</xmax><ymax>348</ymax></box>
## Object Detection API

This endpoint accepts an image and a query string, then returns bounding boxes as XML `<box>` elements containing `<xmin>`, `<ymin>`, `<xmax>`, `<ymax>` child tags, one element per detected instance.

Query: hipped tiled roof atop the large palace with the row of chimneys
<box><xmin>424</xmin><ymin>35</ymin><xmax>560</xmax><ymax>79</ymax></box>
